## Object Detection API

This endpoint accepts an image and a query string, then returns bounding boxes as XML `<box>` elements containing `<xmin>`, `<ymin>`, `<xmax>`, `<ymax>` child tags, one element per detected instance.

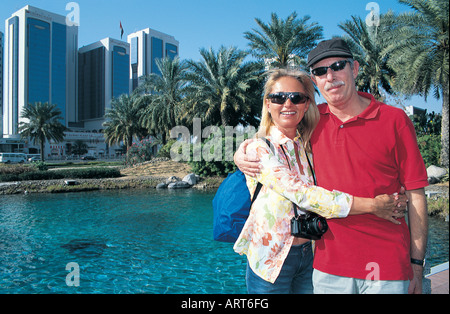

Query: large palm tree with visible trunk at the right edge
<box><xmin>384</xmin><ymin>0</ymin><xmax>449</xmax><ymax>167</ymax></box>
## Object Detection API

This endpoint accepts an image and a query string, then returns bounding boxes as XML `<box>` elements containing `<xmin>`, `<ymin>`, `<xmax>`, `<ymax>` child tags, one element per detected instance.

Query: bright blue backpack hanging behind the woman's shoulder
<box><xmin>213</xmin><ymin>138</ymin><xmax>273</xmax><ymax>243</ymax></box>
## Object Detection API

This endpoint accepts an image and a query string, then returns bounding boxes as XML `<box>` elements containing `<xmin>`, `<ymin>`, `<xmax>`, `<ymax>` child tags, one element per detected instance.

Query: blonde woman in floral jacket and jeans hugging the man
<box><xmin>234</xmin><ymin>69</ymin><xmax>403</xmax><ymax>293</ymax></box>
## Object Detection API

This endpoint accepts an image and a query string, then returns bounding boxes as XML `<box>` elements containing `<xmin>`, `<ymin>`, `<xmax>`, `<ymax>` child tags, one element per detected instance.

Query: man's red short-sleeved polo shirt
<box><xmin>311</xmin><ymin>93</ymin><xmax>428</xmax><ymax>280</ymax></box>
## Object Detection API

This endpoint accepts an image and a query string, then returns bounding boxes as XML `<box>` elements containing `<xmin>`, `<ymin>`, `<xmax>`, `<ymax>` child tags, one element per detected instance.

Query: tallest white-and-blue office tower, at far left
<box><xmin>3</xmin><ymin>5</ymin><xmax>78</xmax><ymax>137</ymax></box>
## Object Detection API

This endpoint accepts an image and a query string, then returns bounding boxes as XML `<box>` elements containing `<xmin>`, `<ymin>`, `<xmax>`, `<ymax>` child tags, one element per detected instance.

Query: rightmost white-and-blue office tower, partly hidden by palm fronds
<box><xmin>127</xmin><ymin>28</ymin><xmax>179</xmax><ymax>91</ymax></box>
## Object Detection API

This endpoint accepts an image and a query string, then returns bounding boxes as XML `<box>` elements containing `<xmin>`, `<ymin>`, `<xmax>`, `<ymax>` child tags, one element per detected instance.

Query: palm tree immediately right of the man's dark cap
<box><xmin>339</xmin><ymin>16</ymin><xmax>394</xmax><ymax>101</ymax></box>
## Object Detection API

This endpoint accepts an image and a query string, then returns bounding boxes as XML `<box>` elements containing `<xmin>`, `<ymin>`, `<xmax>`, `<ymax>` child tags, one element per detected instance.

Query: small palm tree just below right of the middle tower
<box><xmin>103</xmin><ymin>94</ymin><xmax>146</xmax><ymax>149</ymax></box>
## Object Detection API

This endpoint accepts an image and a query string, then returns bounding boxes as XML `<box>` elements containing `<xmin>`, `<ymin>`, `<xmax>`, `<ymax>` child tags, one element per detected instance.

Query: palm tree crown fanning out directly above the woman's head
<box><xmin>244</xmin><ymin>12</ymin><xmax>323</xmax><ymax>67</ymax></box>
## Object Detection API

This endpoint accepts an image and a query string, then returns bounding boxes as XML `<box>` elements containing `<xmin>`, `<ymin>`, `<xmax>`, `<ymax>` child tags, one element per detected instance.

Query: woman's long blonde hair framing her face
<box><xmin>258</xmin><ymin>69</ymin><xmax>320</xmax><ymax>151</ymax></box>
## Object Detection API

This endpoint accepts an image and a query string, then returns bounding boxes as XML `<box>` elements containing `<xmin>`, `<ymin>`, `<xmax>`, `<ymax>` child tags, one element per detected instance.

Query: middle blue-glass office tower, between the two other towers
<box><xmin>78</xmin><ymin>37</ymin><xmax>130</xmax><ymax>130</ymax></box>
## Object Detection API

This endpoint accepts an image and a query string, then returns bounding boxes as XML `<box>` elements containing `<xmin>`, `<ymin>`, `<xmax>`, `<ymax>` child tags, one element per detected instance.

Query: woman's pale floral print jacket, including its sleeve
<box><xmin>234</xmin><ymin>126</ymin><xmax>353</xmax><ymax>283</ymax></box>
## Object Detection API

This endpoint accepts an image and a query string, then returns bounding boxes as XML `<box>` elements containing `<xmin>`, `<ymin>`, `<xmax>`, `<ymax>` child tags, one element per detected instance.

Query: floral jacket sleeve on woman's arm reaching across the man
<box><xmin>248</xmin><ymin>140</ymin><xmax>353</xmax><ymax>218</ymax></box>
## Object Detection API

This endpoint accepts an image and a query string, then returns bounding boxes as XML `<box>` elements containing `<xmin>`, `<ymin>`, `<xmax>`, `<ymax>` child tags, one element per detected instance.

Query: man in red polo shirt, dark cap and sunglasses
<box><xmin>235</xmin><ymin>38</ymin><xmax>428</xmax><ymax>293</ymax></box>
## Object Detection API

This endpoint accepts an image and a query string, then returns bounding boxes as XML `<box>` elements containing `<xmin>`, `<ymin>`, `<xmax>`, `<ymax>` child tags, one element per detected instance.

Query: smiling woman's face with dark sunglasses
<box><xmin>266</xmin><ymin>76</ymin><xmax>310</xmax><ymax>138</ymax></box>
